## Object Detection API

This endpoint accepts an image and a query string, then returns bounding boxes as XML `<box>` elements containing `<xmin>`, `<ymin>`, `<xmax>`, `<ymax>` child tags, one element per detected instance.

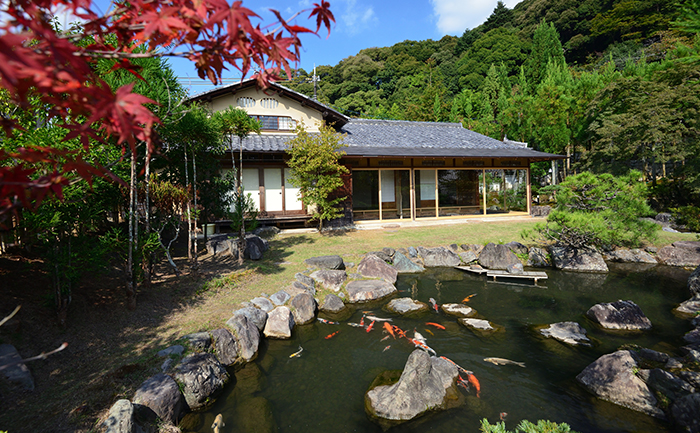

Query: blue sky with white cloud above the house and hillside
<box><xmin>58</xmin><ymin>0</ymin><xmax>520</xmax><ymax>94</ymax></box>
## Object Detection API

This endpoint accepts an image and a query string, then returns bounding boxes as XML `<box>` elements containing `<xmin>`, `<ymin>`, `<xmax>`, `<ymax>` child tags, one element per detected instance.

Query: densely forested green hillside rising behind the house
<box><xmin>284</xmin><ymin>0</ymin><xmax>700</xmax><ymax>204</ymax></box>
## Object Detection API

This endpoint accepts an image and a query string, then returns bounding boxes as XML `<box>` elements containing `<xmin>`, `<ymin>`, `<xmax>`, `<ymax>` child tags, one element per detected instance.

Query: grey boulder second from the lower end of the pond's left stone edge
<box><xmin>132</xmin><ymin>373</ymin><xmax>187</xmax><ymax>425</ymax></box>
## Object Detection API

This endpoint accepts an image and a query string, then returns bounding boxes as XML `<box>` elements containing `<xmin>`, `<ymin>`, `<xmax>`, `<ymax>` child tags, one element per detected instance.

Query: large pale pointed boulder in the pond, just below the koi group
<box><xmin>365</xmin><ymin>350</ymin><xmax>460</xmax><ymax>427</ymax></box>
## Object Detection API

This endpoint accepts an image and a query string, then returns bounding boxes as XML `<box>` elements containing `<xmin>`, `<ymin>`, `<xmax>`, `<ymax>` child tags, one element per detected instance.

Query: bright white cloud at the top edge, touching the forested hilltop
<box><xmin>430</xmin><ymin>0</ymin><xmax>520</xmax><ymax>35</ymax></box>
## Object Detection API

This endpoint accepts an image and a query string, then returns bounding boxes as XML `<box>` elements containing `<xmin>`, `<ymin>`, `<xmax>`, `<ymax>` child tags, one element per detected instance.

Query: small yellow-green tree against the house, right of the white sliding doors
<box><xmin>287</xmin><ymin>124</ymin><xmax>348</xmax><ymax>231</ymax></box>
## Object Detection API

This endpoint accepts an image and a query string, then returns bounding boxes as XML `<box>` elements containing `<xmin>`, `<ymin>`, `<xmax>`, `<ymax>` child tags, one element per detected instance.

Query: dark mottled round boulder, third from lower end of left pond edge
<box><xmin>175</xmin><ymin>353</ymin><xmax>229</xmax><ymax>410</ymax></box>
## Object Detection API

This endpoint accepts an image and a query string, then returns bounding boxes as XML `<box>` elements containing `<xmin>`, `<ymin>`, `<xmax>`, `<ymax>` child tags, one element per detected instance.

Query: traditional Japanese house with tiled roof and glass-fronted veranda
<box><xmin>191</xmin><ymin>79</ymin><xmax>563</xmax><ymax>225</ymax></box>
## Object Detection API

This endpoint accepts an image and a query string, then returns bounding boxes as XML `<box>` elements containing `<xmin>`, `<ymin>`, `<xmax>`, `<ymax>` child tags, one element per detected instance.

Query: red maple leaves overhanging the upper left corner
<box><xmin>0</xmin><ymin>0</ymin><xmax>335</xmax><ymax>221</ymax></box>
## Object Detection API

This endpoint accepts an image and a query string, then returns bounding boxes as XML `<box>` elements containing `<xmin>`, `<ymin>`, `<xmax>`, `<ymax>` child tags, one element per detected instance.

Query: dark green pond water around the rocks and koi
<box><xmin>186</xmin><ymin>265</ymin><xmax>690</xmax><ymax>433</ymax></box>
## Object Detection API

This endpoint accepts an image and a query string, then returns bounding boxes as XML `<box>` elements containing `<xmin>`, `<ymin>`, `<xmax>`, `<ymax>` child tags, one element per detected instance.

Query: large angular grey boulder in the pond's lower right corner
<box><xmin>576</xmin><ymin>350</ymin><xmax>665</xmax><ymax>418</ymax></box>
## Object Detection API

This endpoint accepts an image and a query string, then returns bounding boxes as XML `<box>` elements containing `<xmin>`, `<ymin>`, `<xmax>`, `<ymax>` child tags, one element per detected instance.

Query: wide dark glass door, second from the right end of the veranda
<box><xmin>437</xmin><ymin>170</ymin><xmax>484</xmax><ymax>216</ymax></box>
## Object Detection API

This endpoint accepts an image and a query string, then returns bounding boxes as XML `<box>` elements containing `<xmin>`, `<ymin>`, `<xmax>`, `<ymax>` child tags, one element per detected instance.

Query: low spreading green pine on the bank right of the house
<box><xmin>523</xmin><ymin>170</ymin><xmax>658</xmax><ymax>248</ymax></box>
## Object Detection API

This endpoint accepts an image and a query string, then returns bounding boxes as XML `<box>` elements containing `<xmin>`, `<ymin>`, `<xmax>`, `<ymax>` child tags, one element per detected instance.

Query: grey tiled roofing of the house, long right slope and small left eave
<box><xmin>228</xmin><ymin>119</ymin><xmax>562</xmax><ymax>160</ymax></box>
